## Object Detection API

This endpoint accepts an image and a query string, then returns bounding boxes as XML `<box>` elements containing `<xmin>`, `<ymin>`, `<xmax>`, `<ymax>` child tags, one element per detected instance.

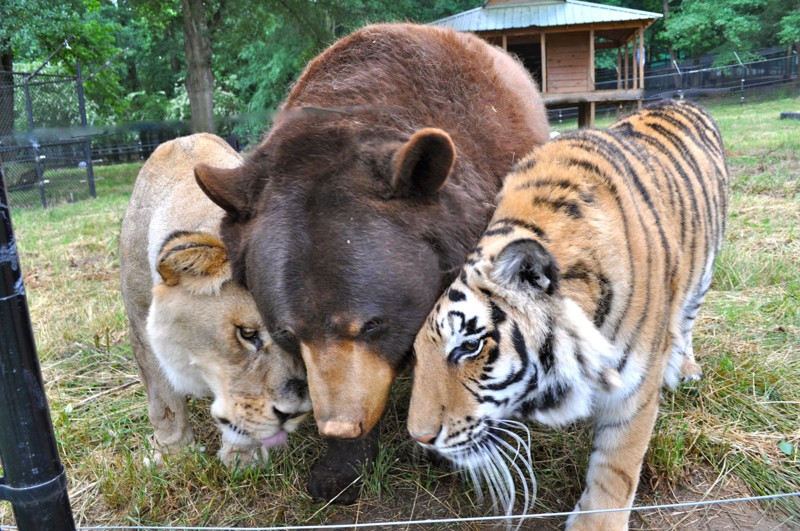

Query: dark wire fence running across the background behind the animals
<box><xmin>0</xmin><ymin>49</ymin><xmax>800</xmax><ymax>208</ymax></box>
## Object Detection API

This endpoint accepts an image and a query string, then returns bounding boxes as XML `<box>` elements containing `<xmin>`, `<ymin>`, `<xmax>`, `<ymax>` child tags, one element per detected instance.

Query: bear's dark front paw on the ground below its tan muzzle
<box><xmin>308</xmin><ymin>427</ymin><xmax>378</xmax><ymax>505</ymax></box>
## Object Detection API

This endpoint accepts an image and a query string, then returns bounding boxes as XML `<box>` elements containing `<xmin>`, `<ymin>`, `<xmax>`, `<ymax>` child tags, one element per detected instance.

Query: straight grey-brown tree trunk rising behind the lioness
<box><xmin>181</xmin><ymin>0</ymin><xmax>216</xmax><ymax>133</ymax></box>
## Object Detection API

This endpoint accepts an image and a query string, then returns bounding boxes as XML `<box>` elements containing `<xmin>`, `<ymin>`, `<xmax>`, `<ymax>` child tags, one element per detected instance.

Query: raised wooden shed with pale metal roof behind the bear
<box><xmin>431</xmin><ymin>0</ymin><xmax>661</xmax><ymax>126</ymax></box>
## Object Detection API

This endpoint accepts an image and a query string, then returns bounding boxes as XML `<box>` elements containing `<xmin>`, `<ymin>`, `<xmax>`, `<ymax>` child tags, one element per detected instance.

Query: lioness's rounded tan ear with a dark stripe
<box><xmin>156</xmin><ymin>232</ymin><xmax>231</xmax><ymax>295</ymax></box>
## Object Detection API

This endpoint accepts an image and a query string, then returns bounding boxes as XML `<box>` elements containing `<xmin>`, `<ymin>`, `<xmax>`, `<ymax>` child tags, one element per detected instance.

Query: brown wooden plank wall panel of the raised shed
<box><xmin>545</xmin><ymin>31</ymin><xmax>594</xmax><ymax>94</ymax></box>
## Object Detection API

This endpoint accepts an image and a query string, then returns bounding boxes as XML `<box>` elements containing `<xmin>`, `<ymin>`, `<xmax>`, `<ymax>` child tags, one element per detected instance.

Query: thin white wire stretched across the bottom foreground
<box><xmin>0</xmin><ymin>492</ymin><xmax>800</xmax><ymax>531</ymax></box>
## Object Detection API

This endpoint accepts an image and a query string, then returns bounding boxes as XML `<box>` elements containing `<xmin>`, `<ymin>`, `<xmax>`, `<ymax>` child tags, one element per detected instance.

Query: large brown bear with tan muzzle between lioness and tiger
<box><xmin>195</xmin><ymin>20</ymin><xmax>549</xmax><ymax>502</ymax></box>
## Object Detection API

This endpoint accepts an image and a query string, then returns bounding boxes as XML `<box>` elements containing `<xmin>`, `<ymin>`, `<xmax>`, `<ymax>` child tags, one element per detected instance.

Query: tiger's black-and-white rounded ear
<box><xmin>490</xmin><ymin>239</ymin><xmax>561</xmax><ymax>295</ymax></box>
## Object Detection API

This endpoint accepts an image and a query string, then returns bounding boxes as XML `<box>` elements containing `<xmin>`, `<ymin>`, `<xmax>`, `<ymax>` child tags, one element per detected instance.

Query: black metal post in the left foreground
<box><xmin>0</xmin><ymin>164</ymin><xmax>75</xmax><ymax>531</ymax></box>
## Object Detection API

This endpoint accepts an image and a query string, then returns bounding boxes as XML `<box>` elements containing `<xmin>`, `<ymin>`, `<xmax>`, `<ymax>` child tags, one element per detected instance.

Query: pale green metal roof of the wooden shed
<box><xmin>431</xmin><ymin>0</ymin><xmax>661</xmax><ymax>31</ymax></box>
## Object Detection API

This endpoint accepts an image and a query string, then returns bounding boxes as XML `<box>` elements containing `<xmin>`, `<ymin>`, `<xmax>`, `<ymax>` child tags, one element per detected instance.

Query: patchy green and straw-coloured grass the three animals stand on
<box><xmin>0</xmin><ymin>96</ymin><xmax>800</xmax><ymax>529</ymax></box>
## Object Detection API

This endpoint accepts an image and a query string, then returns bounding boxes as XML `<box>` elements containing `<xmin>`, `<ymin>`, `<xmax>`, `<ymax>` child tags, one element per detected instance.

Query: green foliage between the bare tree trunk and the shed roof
<box><xmin>209</xmin><ymin>0</ymin><xmax>483</xmax><ymax>140</ymax></box>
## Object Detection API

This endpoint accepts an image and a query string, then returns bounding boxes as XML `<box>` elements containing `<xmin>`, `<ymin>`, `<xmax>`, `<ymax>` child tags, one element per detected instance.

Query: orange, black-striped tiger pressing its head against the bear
<box><xmin>407</xmin><ymin>101</ymin><xmax>728</xmax><ymax>531</ymax></box>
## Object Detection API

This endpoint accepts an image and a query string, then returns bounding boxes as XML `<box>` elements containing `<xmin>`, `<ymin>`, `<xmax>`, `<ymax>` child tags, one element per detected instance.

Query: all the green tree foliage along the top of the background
<box><xmin>0</xmin><ymin>0</ymin><xmax>800</xmax><ymax>139</ymax></box>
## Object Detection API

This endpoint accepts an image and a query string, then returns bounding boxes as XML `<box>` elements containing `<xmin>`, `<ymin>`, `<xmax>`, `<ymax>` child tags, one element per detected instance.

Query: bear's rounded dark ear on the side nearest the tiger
<box><xmin>392</xmin><ymin>128</ymin><xmax>456</xmax><ymax>197</ymax></box>
